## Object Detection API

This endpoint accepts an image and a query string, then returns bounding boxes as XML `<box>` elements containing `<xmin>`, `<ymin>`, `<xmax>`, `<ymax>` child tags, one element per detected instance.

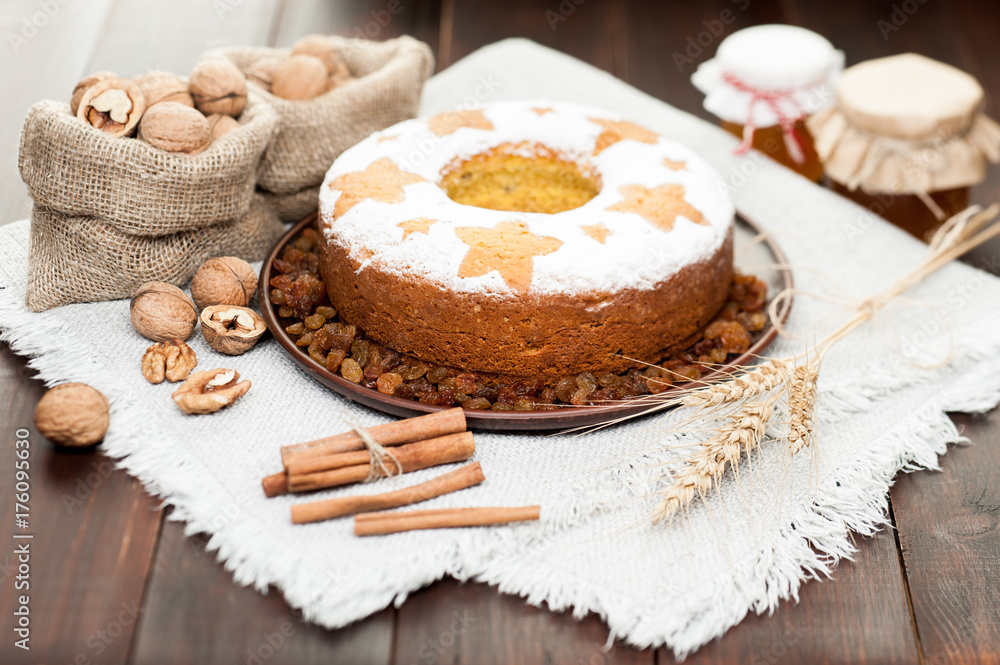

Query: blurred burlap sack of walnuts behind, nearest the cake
<box><xmin>215</xmin><ymin>36</ymin><xmax>434</xmax><ymax>221</ymax></box>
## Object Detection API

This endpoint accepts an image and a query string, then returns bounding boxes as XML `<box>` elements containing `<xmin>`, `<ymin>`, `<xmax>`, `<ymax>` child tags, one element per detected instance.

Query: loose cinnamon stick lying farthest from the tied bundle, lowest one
<box><xmin>354</xmin><ymin>506</ymin><xmax>541</xmax><ymax>536</ymax></box>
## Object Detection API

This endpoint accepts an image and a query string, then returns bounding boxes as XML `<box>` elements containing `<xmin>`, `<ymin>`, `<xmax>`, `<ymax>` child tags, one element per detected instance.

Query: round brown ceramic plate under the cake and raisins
<box><xmin>257</xmin><ymin>215</ymin><xmax>792</xmax><ymax>431</ymax></box>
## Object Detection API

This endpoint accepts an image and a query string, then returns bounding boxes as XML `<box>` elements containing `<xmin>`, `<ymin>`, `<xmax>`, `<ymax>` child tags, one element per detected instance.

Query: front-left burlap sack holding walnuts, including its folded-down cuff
<box><xmin>19</xmin><ymin>87</ymin><xmax>282</xmax><ymax>311</ymax></box>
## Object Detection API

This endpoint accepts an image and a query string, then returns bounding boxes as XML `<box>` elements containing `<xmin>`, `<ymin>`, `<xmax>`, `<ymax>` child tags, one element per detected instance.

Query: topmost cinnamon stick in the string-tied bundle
<box><xmin>281</xmin><ymin>406</ymin><xmax>465</xmax><ymax>470</ymax></box>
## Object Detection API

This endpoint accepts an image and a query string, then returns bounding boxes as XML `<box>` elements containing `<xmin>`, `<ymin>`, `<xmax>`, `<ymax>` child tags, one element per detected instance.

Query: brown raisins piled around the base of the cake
<box><xmin>269</xmin><ymin>227</ymin><xmax>767</xmax><ymax>411</ymax></box>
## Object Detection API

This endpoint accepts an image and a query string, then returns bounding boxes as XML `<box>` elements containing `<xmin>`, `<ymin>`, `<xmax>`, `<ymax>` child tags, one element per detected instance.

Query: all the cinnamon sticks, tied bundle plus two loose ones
<box><xmin>262</xmin><ymin>407</ymin><xmax>540</xmax><ymax>536</ymax></box>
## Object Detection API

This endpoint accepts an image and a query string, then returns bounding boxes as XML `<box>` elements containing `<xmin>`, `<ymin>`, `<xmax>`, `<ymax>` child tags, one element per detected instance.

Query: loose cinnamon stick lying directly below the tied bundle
<box><xmin>292</xmin><ymin>462</ymin><xmax>485</xmax><ymax>524</ymax></box>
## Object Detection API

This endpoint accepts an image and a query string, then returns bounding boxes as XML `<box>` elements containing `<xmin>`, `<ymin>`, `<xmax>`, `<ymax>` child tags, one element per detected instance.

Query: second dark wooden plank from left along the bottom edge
<box><xmin>130</xmin><ymin>522</ymin><xmax>393</xmax><ymax>665</ymax></box>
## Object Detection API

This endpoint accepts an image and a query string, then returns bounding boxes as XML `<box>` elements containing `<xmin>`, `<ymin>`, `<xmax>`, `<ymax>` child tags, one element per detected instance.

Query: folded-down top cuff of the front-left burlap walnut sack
<box><xmin>19</xmin><ymin>91</ymin><xmax>278</xmax><ymax>237</ymax></box>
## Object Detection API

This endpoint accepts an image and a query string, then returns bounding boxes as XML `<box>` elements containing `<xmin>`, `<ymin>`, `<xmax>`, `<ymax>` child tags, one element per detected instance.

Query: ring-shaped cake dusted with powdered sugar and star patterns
<box><xmin>320</xmin><ymin>102</ymin><xmax>734</xmax><ymax>376</ymax></box>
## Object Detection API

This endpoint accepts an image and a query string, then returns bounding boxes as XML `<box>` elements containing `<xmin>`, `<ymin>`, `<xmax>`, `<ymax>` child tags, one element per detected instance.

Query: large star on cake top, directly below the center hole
<box><xmin>455</xmin><ymin>222</ymin><xmax>562</xmax><ymax>292</ymax></box>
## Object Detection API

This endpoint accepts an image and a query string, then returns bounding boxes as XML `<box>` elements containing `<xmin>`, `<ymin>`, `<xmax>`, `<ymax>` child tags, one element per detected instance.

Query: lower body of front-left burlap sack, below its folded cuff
<box><xmin>25</xmin><ymin>195</ymin><xmax>284</xmax><ymax>312</ymax></box>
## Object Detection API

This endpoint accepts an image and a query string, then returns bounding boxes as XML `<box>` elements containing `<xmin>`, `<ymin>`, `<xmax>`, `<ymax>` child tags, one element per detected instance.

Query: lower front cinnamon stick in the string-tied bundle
<box><xmin>288</xmin><ymin>432</ymin><xmax>476</xmax><ymax>492</ymax></box>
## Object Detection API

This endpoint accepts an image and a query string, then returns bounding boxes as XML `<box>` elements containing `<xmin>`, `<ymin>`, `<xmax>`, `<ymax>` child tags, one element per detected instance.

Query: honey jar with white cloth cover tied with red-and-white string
<box><xmin>691</xmin><ymin>25</ymin><xmax>844</xmax><ymax>182</ymax></box>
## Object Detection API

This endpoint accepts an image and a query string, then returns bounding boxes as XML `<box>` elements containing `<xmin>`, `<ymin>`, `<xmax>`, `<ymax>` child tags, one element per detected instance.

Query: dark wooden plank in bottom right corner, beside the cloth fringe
<box><xmin>892</xmin><ymin>410</ymin><xmax>1000</xmax><ymax>665</ymax></box>
